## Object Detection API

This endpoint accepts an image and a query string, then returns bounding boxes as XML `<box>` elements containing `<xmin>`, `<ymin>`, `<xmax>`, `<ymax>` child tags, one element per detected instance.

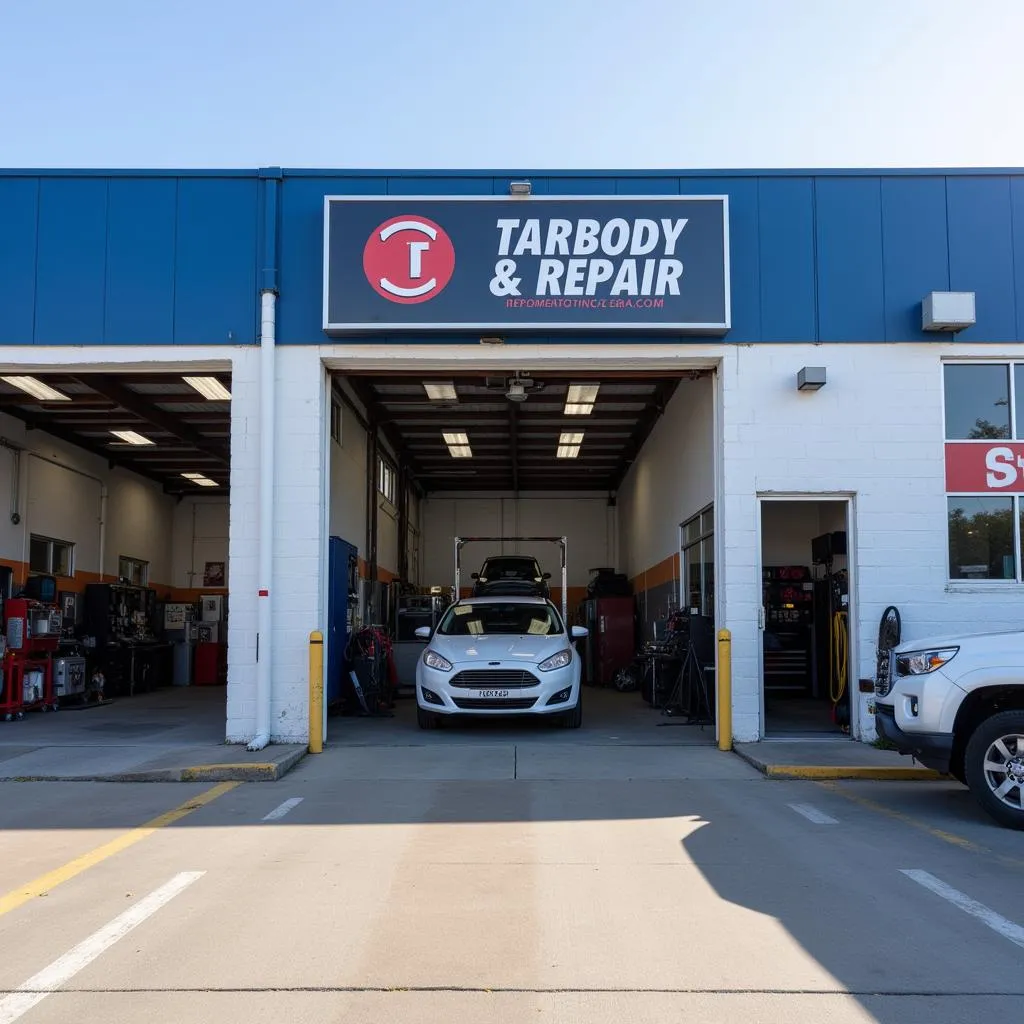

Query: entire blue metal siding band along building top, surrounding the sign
<box><xmin>0</xmin><ymin>170</ymin><xmax>1024</xmax><ymax>345</ymax></box>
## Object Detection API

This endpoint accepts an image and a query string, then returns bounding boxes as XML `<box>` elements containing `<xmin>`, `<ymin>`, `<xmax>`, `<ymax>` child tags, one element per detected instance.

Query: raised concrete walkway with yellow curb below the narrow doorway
<box><xmin>733</xmin><ymin>737</ymin><xmax>947</xmax><ymax>781</ymax></box>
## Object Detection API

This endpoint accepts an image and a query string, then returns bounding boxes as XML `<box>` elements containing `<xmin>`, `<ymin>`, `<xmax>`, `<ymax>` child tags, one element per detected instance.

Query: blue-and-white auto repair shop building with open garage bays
<box><xmin>0</xmin><ymin>169</ymin><xmax>1024</xmax><ymax>744</ymax></box>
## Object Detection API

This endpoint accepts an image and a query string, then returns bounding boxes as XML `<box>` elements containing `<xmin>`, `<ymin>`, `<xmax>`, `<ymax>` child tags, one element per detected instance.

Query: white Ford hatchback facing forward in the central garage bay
<box><xmin>416</xmin><ymin>597</ymin><xmax>587</xmax><ymax>729</ymax></box>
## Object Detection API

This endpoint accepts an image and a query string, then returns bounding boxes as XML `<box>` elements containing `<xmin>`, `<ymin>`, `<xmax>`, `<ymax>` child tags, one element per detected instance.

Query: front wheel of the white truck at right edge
<box><xmin>964</xmin><ymin>711</ymin><xmax>1024</xmax><ymax>829</ymax></box>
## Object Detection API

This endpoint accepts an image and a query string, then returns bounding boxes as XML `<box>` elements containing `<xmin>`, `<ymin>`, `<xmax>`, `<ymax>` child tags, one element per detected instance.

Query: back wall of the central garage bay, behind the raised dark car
<box><xmin>422</xmin><ymin>493</ymin><xmax>617</xmax><ymax>609</ymax></box>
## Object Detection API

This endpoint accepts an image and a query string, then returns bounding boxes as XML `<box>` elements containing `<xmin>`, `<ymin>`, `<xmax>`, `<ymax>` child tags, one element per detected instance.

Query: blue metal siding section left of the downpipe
<box><xmin>0</xmin><ymin>172</ymin><xmax>260</xmax><ymax>345</ymax></box>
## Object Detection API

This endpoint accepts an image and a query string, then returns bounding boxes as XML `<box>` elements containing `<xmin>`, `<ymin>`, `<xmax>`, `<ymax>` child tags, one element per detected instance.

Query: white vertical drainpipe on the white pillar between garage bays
<box><xmin>247</xmin><ymin>290</ymin><xmax>278</xmax><ymax>751</ymax></box>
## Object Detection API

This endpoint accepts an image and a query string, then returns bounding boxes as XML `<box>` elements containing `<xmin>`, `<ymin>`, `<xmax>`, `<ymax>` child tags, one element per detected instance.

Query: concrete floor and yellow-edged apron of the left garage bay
<box><xmin>0</xmin><ymin>687</ymin><xmax>306</xmax><ymax>782</ymax></box>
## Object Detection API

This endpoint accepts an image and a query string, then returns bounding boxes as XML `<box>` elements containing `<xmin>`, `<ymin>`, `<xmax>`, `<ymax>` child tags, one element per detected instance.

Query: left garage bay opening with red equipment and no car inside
<box><xmin>0</xmin><ymin>372</ymin><xmax>231</xmax><ymax>743</ymax></box>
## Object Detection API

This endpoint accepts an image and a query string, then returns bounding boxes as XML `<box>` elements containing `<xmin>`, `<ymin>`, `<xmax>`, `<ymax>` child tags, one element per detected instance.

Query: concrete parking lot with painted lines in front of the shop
<box><xmin>0</xmin><ymin>733</ymin><xmax>1024</xmax><ymax>1024</ymax></box>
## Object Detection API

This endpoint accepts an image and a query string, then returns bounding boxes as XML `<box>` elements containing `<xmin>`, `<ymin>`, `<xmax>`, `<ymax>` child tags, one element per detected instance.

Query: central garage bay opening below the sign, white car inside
<box><xmin>326</xmin><ymin>367</ymin><xmax>715</xmax><ymax>742</ymax></box>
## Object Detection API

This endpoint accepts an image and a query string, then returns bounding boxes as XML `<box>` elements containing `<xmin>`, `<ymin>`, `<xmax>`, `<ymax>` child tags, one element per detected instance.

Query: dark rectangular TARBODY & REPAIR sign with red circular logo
<box><xmin>324</xmin><ymin>196</ymin><xmax>730</xmax><ymax>335</ymax></box>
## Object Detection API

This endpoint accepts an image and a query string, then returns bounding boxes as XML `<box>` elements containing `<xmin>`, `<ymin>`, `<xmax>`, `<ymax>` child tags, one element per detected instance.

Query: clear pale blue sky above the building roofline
<box><xmin>0</xmin><ymin>0</ymin><xmax>1024</xmax><ymax>170</ymax></box>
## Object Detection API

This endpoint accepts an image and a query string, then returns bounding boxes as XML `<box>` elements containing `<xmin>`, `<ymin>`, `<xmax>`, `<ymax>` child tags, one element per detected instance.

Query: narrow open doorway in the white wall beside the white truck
<box><xmin>760</xmin><ymin>496</ymin><xmax>854</xmax><ymax>736</ymax></box>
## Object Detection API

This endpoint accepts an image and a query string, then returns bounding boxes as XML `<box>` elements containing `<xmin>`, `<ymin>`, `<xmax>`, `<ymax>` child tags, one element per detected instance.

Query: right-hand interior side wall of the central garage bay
<box><xmin>618</xmin><ymin>376</ymin><xmax>715</xmax><ymax>631</ymax></box>
